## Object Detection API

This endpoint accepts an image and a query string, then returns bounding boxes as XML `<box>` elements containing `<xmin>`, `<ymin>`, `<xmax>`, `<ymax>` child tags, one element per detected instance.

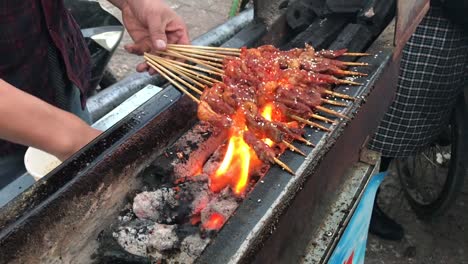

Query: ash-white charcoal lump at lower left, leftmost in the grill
<box><xmin>113</xmin><ymin>219</ymin><xmax>153</xmax><ymax>256</ymax></box>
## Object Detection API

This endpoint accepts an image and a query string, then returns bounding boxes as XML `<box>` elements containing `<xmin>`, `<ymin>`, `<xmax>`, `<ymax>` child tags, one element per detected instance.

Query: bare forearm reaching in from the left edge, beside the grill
<box><xmin>0</xmin><ymin>79</ymin><xmax>101</xmax><ymax>161</ymax></box>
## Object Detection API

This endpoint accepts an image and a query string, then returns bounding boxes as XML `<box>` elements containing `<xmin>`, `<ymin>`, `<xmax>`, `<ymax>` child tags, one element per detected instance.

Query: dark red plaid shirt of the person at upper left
<box><xmin>0</xmin><ymin>0</ymin><xmax>91</xmax><ymax>157</ymax></box>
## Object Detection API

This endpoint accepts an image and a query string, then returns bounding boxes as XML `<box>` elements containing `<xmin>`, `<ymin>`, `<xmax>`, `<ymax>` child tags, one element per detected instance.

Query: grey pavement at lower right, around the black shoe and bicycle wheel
<box><xmin>366</xmin><ymin>164</ymin><xmax>468</xmax><ymax>264</ymax></box>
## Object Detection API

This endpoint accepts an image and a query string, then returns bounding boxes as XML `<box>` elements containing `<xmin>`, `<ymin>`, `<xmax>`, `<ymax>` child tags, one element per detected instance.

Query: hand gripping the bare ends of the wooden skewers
<box><xmin>121</xmin><ymin>0</ymin><xmax>190</xmax><ymax>74</ymax></box>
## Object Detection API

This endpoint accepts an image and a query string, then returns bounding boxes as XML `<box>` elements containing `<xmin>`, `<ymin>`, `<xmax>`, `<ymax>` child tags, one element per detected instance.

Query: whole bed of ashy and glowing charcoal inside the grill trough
<box><xmin>95</xmin><ymin>123</ymin><xmax>268</xmax><ymax>263</ymax></box>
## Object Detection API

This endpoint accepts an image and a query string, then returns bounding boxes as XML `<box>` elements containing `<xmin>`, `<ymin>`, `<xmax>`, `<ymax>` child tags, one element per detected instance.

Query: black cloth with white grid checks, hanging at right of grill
<box><xmin>368</xmin><ymin>6</ymin><xmax>468</xmax><ymax>157</ymax></box>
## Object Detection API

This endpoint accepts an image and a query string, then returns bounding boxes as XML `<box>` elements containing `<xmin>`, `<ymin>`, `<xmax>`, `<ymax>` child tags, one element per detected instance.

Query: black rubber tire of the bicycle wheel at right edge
<box><xmin>395</xmin><ymin>97</ymin><xmax>468</xmax><ymax>220</ymax></box>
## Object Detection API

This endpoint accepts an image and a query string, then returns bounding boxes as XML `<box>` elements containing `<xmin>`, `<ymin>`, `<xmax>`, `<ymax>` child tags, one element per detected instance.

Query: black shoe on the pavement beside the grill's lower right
<box><xmin>369</xmin><ymin>201</ymin><xmax>405</xmax><ymax>241</ymax></box>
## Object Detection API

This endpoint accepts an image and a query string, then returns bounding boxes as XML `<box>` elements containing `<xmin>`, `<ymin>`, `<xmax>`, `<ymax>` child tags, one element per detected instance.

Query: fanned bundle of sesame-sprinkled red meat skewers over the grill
<box><xmin>145</xmin><ymin>45</ymin><xmax>368</xmax><ymax>174</ymax></box>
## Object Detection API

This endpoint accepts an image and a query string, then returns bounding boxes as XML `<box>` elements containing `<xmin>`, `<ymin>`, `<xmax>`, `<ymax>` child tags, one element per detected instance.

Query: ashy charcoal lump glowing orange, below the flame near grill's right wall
<box><xmin>201</xmin><ymin>195</ymin><xmax>238</xmax><ymax>230</ymax></box>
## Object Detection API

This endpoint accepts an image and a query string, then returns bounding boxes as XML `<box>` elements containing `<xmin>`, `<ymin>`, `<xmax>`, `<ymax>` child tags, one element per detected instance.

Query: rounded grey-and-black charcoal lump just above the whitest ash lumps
<box><xmin>133</xmin><ymin>188</ymin><xmax>179</xmax><ymax>223</ymax></box>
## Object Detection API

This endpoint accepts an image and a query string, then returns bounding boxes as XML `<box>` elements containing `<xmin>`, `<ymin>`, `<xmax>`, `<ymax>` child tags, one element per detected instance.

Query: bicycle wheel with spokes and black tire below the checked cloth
<box><xmin>396</xmin><ymin>98</ymin><xmax>468</xmax><ymax>220</ymax></box>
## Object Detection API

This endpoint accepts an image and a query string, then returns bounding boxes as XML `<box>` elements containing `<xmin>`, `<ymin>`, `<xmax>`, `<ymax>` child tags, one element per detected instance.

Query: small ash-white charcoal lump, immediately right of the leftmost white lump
<box><xmin>148</xmin><ymin>223</ymin><xmax>179</xmax><ymax>253</ymax></box>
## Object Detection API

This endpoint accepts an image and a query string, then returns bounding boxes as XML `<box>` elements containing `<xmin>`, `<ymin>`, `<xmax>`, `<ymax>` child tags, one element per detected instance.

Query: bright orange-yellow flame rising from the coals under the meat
<box><xmin>210</xmin><ymin>104</ymin><xmax>274</xmax><ymax>195</ymax></box>
